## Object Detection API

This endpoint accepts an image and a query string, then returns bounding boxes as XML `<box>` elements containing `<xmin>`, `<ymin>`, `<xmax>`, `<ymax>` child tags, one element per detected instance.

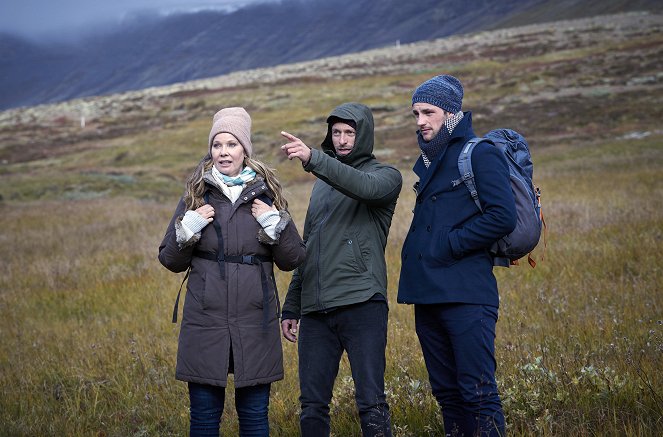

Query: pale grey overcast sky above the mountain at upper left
<box><xmin>0</xmin><ymin>0</ymin><xmax>277</xmax><ymax>37</ymax></box>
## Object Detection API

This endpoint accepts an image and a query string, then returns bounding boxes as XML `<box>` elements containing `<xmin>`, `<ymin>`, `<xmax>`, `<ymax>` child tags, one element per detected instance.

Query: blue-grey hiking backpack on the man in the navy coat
<box><xmin>453</xmin><ymin>129</ymin><xmax>545</xmax><ymax>267</ymax></box>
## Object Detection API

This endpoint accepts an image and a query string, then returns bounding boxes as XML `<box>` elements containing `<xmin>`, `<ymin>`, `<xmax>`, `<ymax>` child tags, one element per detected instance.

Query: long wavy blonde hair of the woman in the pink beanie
<box><xmin>184</xmin><ymin>153</ymin><xmax>288</xmax><ymax>211</ymax></box>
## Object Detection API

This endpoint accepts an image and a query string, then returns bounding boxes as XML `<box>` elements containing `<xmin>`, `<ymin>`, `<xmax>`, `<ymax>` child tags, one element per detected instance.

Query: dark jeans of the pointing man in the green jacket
<box><xmin>298</xmin><ymin>301</ymin><xmax>391</xmax><ymax>437</ymax></box>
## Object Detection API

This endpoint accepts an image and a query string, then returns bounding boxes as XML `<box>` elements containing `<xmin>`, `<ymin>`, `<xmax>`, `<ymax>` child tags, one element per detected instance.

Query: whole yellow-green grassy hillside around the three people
<box><xmin>0</xmin><ymin>11</ymin><xmax>663</xmax><ymax>437</ymax></box>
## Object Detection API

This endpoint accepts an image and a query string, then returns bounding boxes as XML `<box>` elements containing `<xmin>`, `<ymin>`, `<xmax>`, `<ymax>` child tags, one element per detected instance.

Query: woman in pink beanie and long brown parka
<box><xmin>159</xmin><ymin>107</ymin><xmax>306</xmax><ymax>437</ymax></box>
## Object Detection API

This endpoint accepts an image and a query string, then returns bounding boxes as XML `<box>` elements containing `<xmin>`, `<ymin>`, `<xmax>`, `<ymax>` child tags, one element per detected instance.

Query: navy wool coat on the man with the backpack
<box><xmin>398</xmin><ymin>112</ymin><xmax>516</xmax><ymax>307</ymax></box>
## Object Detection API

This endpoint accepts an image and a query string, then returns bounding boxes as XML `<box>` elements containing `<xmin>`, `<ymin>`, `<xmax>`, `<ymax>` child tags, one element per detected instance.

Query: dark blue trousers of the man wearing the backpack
<box><xmin>414</xmin><ymin>304</ymin><xmax>505</xmax><ymax>437</ymax></box>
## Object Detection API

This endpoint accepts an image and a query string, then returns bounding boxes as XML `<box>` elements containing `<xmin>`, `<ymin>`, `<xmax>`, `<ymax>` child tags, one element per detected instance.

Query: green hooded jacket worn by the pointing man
<box><xmin>282</xmin><ymin>103</ymin><xmax>403</xmax><ymax>320</ymax></box>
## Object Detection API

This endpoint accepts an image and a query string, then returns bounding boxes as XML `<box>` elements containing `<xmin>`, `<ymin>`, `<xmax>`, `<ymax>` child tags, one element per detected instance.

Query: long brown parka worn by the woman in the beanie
<box><xmin>159</xmin><ymin>173</ymin><xmax>306</xmax><ymax>388</ymax></box>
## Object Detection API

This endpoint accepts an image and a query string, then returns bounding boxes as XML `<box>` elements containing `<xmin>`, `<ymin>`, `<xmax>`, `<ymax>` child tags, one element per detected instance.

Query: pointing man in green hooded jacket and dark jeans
<box><xmin>281</xmin><ymin>103</ymin><xmax>403</xmax><ymax>437</ymax></box>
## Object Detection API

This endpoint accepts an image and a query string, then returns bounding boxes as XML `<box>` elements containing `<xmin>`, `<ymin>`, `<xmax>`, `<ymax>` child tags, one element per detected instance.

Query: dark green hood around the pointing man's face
<box><xmin>321</xmin><ymin>102</ymin><xmax>374</xmax><ymax>166</ymax></box>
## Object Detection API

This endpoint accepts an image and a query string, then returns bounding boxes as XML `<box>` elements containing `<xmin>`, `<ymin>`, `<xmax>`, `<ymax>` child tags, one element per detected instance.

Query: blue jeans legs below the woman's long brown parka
<box><xmin>189</xmin><ymin>382</ymin><xmax>271</xmax><ymax>437</ymax></box>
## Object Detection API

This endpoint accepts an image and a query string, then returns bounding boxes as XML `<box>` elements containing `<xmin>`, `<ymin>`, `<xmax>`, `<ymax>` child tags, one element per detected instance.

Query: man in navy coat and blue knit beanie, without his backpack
<box><xmin>398</xmin><ymin>75</ymin><xmax>516</xmax><ymax>437</ymax></box>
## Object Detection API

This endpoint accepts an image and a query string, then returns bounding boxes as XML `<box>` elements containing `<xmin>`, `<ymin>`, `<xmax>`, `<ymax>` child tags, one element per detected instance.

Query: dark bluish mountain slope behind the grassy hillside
<box><xmin>0</xmin><ymin>0</ymin><xmax>661</xmax><ymax>110</ymax></box>
